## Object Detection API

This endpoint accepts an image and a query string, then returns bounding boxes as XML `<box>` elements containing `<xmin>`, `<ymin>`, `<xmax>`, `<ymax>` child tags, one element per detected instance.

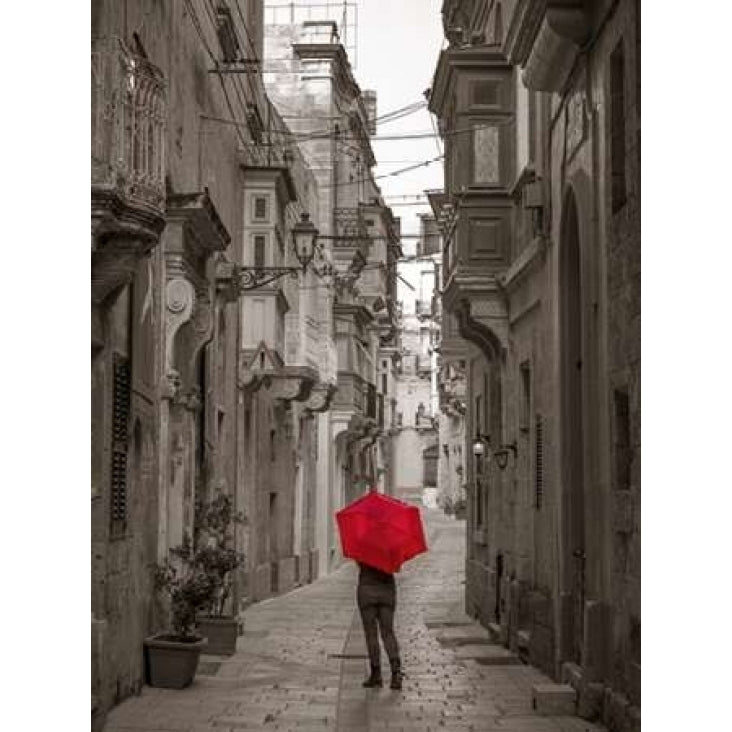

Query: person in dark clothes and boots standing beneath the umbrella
<box><xmin>356</xmin><ymin>562</ymin><xmax>402</xmax><ymax>690</ymax></box>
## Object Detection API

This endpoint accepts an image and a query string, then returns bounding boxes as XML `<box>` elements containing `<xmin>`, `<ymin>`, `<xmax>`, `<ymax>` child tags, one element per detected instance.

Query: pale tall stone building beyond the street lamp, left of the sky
<box><xmin>265</xmin><ymin>12</ymin><xmax>401</xmax><ymax>573</ymax></box>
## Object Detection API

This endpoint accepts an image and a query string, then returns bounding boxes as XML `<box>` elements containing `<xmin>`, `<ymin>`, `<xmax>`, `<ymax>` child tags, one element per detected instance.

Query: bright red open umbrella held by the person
<box><xmin>336</xmin><ymin>491</ymin><xmax>427</xmax><ymax>573</ymax></box>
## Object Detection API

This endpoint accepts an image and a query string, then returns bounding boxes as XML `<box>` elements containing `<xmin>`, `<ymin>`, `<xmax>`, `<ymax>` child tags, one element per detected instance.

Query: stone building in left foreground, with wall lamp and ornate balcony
<box><xmin>91</xmin><ymin>0</ymin><xmax>337</xmax><ymax>727</ymax></box>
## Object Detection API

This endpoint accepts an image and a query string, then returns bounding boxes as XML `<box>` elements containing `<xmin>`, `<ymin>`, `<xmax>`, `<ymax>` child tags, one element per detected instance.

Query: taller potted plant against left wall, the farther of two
<box><xmin>195</xmin><ymin>493</ymin><xmax>244</xmax><ymax>656</ymax></box>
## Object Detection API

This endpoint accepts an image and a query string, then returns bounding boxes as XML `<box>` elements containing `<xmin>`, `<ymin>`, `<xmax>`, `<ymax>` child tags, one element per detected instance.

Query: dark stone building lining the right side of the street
<box><xmin>429</xmin><ymin>0</ymin><xmax>640</xmax><ymax>730</ymax></box>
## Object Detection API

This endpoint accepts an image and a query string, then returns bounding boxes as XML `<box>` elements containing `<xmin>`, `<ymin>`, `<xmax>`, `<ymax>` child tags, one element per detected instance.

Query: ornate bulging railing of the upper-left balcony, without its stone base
<box><xmin>91</xmin><ymin>37</ymin><xmax>166</xmax><ymax>209</ymax></box>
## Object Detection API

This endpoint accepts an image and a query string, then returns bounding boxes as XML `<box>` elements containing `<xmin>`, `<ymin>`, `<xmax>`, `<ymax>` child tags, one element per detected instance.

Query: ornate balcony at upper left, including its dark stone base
<box><xmin>91</xmin><ymin>37</ymin><xmax>166</xmax><ymax>305</ymax></box>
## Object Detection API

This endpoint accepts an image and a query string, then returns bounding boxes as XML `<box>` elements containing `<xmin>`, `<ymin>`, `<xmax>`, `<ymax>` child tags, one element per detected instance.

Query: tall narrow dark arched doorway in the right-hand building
<box><xmin>559</xmin><ymin>189</ymin><xmax>586</xmax><ymax>664</ymax></box>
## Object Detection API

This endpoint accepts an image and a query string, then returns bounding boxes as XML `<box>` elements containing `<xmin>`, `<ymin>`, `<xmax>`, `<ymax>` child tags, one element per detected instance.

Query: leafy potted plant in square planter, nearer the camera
<box><xmin>145</xmin><ymin>534</ymin><xmax>214</xmax><ymax>689</ymax></box>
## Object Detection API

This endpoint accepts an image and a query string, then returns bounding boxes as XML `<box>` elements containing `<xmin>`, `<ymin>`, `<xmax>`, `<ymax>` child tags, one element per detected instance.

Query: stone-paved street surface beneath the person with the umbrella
<box><xmin>105</xmin><ymin>510</ymin><xmax>603</xmax><ymax>732</ymax></box>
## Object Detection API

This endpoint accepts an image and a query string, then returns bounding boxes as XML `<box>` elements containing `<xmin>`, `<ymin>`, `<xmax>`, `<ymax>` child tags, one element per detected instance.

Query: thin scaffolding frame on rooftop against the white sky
<box><xmin>264</xmin><ymin>0</ymin><xmax>358</xmax><ymax>69</ymax></box>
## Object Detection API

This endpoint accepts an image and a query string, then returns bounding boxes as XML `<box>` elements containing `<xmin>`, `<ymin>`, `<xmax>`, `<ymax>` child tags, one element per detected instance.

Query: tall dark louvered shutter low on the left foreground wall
<box><xmin>110</xmin><ymin>354</ymin><xmax>130</xmax><ymax>533</ymax></box>
